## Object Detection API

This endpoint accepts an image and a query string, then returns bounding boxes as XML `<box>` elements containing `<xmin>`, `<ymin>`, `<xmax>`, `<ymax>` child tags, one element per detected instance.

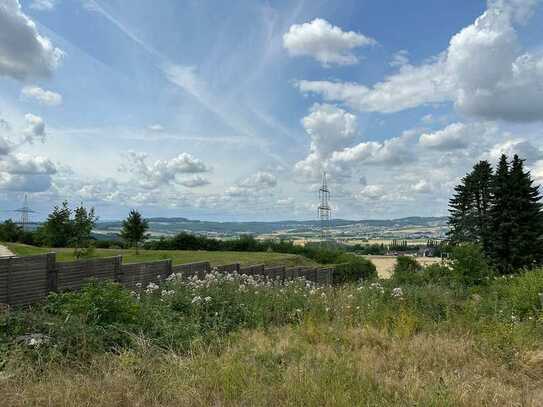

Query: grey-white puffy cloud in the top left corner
<box><xmin>0</xmin><ymin>0</ymin><xmax>63</xmax><ymax>80</ymax></box>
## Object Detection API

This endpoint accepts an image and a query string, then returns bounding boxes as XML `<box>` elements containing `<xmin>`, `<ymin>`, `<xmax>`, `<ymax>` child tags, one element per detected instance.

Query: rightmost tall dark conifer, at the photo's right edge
<box><xmin>509</xmin><ymin>155</ymin><xmax>543</xmax><ymax>269</ymax></box>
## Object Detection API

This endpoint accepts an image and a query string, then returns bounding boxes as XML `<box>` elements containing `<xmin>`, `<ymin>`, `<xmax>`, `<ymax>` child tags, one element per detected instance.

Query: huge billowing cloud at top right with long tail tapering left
<box><xmin>296</xmin><ymin>0</ymin><xmax>543</xmax><ymax>122</ymax></box>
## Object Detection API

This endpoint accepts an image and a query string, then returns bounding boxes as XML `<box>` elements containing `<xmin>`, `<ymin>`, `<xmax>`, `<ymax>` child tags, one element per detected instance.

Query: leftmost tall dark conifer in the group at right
<box><xmin>448</xmin><ymin>161</ymin><xmax>492</xmax><ymax>252</ymax></box>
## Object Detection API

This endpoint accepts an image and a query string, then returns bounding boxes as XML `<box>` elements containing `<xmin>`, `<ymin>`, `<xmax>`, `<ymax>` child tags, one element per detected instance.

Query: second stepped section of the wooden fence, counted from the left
<box><xmin>56</xmin><ymin>256</ymin><xmax>122</xmax><ymax>291</ymax></box>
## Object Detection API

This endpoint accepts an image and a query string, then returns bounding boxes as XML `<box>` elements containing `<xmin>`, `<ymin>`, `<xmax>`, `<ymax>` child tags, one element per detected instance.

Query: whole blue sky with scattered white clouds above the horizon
<box><xmin>0</xmin><ymin>0</ymin><xmax>543</xmax><ymax>221</ymax></box>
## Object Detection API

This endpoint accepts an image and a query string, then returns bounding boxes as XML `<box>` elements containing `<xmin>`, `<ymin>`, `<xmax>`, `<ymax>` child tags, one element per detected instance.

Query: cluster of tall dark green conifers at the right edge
<box><xmin>448</xmin><ymin>154</ymin><xmax>543</xmax><ymax>274</ymax></box>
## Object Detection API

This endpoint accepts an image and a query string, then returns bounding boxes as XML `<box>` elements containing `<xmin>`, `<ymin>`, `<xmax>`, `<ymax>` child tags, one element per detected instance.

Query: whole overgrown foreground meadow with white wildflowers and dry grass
<box><xmin>0</xmin><ymin>258</ymin><xmax>543</xmax><ymax>406</ymax></box>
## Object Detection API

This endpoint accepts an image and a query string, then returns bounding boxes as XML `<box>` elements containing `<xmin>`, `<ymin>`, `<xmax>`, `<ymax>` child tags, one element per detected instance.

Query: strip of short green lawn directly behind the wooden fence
<box><xmin>5</xmin><ymin>243</ymin><xmax>316</xmax><ymax>266</ymax></box>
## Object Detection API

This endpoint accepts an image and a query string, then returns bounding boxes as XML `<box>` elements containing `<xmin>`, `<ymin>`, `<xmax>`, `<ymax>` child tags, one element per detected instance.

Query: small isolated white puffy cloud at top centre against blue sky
<box><xmin>283</xmin><ymin>18</ymin><xmax>377</xmax><ymax>67</ymax></box>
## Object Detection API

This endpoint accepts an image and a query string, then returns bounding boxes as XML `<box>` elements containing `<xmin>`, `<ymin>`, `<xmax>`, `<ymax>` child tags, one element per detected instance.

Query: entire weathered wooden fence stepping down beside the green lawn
<box><xmin>0</xmin><ymin>253</ymin><xmax>334</xmax><ymax>306</ymax></box>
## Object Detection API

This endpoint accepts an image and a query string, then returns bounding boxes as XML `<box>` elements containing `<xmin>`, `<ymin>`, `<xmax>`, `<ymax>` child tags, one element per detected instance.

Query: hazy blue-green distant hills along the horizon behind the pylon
<box><xmin>96</xmin><ymin>216</ymin><xmax>447</xmax><ymax>235</ymax></box>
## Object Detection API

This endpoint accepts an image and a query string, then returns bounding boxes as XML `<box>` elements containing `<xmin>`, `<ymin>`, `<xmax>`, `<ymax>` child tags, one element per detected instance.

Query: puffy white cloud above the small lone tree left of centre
<box><xmin>120</xmin><ymin>151</ymin><xmax>210</xmax><ymax>189</ymax></box>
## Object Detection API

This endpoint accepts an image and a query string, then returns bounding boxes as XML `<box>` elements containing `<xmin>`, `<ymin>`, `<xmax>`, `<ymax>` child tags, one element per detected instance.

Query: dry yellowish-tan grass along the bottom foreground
<box><xmin>0</xmin><ymin>322</ymin><xmax>543</xmax><ymax>407</ymax></box>
